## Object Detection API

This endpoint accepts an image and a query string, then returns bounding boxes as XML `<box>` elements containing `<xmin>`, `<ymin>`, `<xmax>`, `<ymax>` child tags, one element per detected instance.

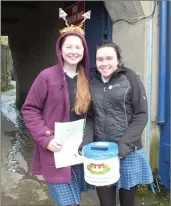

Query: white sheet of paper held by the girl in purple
<box><xmin>54</xmin><ymin>119</ymin><xmax>84</xmax><ymax>168</ymax></box>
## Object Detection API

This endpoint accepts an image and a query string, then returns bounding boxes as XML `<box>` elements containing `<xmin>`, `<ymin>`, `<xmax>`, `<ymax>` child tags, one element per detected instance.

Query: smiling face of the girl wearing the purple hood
<box><xmin>62</xmin><ymin>35</ymin><xmax>84</xmax><ymax>65</ymax></box>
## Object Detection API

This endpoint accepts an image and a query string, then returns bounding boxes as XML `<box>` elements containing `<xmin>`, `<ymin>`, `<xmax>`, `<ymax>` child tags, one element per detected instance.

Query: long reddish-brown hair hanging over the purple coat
<box><xmin>61</xmin><ymin>36</ymin><xmax>91</xmax><ymax>115</ymax></box>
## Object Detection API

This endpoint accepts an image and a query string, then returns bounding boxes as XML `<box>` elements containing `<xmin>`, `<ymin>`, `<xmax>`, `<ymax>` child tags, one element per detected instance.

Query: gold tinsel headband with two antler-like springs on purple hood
<box><xmin>59</xmin><ymin>8</ymin><xmax>91</xmax><ymax>35</ymax></box>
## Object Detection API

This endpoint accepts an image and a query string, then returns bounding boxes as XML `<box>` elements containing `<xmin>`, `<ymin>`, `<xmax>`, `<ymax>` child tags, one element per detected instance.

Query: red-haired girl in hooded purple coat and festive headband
<box><xmin>22</xmin><ymin>10</ymin><xmax>94</xmax><ymax>206</ymax></box>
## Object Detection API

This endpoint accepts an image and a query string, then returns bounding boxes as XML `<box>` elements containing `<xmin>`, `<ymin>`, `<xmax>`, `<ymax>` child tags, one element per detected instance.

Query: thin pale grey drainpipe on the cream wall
<box><xmin>145</xmin><ymin>3</ymin><xmax>154</xmax><ymax>160</ymax></box>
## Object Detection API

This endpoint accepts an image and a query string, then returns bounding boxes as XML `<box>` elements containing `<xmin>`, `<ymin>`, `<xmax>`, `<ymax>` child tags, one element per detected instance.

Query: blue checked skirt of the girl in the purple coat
<box><xmin>48</xmin><ymin>164</ymin><xmax>95</xmax><ymax>206</ymax></box>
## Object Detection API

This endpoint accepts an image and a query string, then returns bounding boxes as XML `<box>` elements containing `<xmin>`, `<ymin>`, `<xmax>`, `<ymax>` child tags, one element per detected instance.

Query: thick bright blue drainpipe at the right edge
<box><xmin>157</xmin><ymin>1</ymin><xmax>167</xmax><ymax>125</ymax></box>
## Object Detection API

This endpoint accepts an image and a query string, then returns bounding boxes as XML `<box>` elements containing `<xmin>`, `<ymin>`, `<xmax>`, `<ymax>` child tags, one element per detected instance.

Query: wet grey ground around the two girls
<box><xmin>1</xmin><ymin>85</ymin><xmax>169</xmax><ymax>206</ymax></box>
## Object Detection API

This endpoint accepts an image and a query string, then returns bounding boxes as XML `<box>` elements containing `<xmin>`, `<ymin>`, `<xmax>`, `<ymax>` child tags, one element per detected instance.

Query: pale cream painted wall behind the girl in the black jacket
<box><xmin>105</xmin><ymin>0</ymin><xmax>160</xmax><ymax>165</ymax></box>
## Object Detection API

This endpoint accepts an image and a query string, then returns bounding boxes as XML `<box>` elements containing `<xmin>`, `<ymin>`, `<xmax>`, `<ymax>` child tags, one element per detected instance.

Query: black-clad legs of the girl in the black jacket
<box><xmin>96</xmin><ymin>186</ymin><xmax>137</xmax><ymax>206</ymax></box>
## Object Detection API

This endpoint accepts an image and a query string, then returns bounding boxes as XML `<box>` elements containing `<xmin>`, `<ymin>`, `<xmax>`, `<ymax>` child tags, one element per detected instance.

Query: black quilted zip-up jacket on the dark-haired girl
<box><xmin>90</xmin><ymin>67</ymin><xmax>148</xmax><ymax>158</ymax></box>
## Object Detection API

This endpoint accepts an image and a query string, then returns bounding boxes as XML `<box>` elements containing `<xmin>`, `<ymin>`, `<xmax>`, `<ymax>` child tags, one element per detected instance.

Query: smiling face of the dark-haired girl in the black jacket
<box><xmin>96</xmin><ymin>47</ymin><xmax>119</xmax><ymax>80</ymax></box>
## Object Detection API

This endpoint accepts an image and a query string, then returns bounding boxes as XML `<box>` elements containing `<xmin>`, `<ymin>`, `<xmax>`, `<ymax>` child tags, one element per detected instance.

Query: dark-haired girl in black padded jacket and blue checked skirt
<box><xmin>90</xmin><ymin>42</ymin><xmax>153</xmax><ymax>206</ymax></box>
